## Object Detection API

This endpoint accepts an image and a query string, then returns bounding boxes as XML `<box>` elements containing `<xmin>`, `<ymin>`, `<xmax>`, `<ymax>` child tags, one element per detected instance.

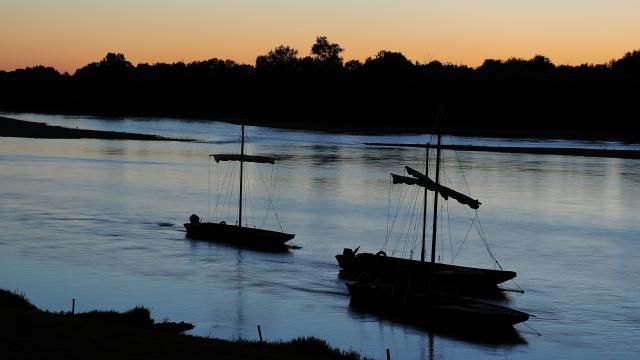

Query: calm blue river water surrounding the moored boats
<box><xmin>0</xmin><ymin>114</ymin><xmax>640</xmax><ymax>359</ymax></box>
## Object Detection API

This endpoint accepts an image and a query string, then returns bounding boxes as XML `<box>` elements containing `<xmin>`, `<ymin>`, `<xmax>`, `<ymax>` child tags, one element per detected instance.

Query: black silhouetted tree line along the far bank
<box><xmin>0</xmin><ymin>36</ymin><xmax>640</xmax><ymax>140</ymax></box>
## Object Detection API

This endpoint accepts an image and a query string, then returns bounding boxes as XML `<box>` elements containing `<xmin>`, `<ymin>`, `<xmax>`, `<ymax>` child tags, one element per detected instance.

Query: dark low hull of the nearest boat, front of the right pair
<box><xmin>347</xmin><ymin>281</ymin><xmax>529</xmax><ymax>331</ymax></box>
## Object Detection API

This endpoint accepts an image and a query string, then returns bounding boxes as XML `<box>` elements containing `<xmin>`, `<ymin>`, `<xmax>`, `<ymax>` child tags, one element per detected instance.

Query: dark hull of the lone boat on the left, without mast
<box><xmin>184</xmin><ymin>222</ymin><xmax>295</xmax><ymax>250</ymax></box>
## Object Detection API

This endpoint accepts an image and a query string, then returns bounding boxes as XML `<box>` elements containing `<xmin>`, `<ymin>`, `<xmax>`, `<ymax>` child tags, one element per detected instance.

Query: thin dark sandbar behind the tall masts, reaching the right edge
<box><xmin>365</xmin><ymin>143</ymin><xmax>640</xmax><ymax>159</ymax></box>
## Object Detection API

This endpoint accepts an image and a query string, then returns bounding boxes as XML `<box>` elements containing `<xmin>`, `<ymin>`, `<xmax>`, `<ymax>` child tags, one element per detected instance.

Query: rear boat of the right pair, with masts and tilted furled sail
<box><xmin>336</xmin><ymin>118</ymin><xmax>516</xmax><ymax>295</ymax></box>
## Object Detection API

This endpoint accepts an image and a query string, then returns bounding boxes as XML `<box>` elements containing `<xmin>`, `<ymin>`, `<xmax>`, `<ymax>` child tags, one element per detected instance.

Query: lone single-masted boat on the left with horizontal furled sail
<box><xmin>184</xmin><ymin>125</ymin><xmax>295</xmax><ymax>250</ymax></box>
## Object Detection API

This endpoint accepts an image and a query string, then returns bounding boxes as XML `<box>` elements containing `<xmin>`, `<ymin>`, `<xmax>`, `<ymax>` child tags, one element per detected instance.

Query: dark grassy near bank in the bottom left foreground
<box><xmin>0</xmin><ymin>290</ymin><xmax>360</xmax><ymax>360</ymax></box>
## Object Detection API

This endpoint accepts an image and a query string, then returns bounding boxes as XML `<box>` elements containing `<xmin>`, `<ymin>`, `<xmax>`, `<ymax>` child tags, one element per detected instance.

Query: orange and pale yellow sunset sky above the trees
<box><xmin>0</xmin><ymin>0</ymin><xmax>640</xmax><ymax>73</ymax></box>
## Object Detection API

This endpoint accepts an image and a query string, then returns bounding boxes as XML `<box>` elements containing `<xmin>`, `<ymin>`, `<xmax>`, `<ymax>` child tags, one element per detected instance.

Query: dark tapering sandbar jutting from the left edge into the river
<box><xmin>0</xmin><ymin>116</ymin><xmax>194</xmax><ymax>141</ymax></box>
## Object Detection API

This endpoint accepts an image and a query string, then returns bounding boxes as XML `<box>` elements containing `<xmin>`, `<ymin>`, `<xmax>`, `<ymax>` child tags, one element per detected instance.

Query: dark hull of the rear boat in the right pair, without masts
<box><xmin>336</xmin><ymin>249</ymin><xmax>516</xmax><ymax>295</ymax></box>
